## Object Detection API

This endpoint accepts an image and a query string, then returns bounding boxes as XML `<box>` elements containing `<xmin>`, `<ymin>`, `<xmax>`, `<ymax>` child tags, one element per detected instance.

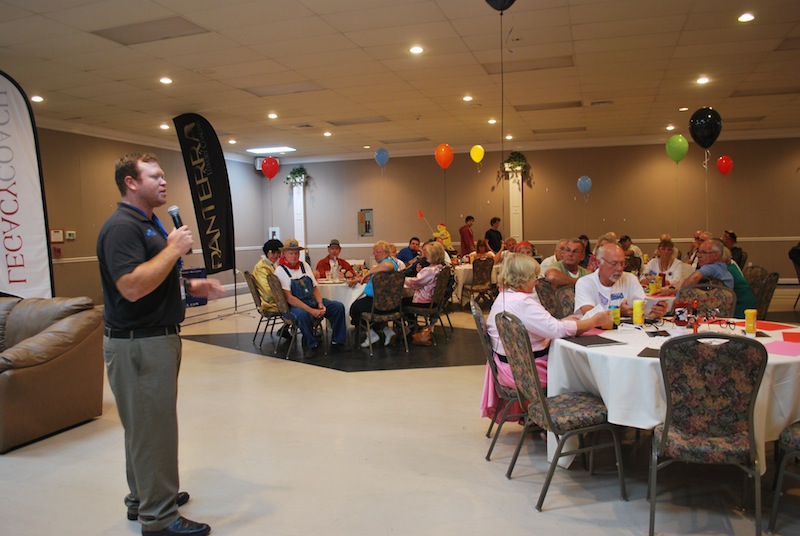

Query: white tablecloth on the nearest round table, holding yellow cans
<box><xmin>547</xmin><ymin>322</ymin><xmax>800</xmax><ymax>471</ymax></box>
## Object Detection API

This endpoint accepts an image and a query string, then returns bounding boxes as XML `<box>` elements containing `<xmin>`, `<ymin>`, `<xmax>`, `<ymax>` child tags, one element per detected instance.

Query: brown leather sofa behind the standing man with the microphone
<box><xmin>0</xmin><ymin>297</ymin><xmax>103</xmax><ymax>453</ymax></box>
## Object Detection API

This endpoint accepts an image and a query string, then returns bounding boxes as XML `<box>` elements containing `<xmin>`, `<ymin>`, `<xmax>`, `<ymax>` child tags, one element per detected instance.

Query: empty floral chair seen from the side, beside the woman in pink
<box><xmin>496</xmin><ymin>312</ymin><xmax>628</xmax><ymax>511</ymax></box>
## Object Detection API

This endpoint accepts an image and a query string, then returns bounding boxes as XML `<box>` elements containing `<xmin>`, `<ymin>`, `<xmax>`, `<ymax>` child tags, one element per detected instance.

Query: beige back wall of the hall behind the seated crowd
<box><xmin>39</xmin><ymin>129</ymin><xmax>800</xmax><ymax>302</ymax></box>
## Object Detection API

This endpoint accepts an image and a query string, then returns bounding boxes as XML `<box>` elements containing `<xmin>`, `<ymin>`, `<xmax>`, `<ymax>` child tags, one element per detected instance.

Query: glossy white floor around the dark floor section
<box><xmin>0</xmin><ymin>289</ymin><xmax>800</xmax><ymax>536</ymax></box>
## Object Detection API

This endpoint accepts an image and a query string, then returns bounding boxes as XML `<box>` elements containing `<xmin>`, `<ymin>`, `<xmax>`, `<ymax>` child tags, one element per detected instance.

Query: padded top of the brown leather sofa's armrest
<box><xmin>0</xmin><ymin>307</ymin><xmax>102</xmax><ymax>372</ymax></box>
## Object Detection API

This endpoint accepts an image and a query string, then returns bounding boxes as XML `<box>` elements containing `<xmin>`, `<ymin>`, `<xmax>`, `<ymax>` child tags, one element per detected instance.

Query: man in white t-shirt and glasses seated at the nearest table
<box><xmin>575</xmin><ymin>243</ymin><xmax>667</xmax><ymax>318</ymax></box>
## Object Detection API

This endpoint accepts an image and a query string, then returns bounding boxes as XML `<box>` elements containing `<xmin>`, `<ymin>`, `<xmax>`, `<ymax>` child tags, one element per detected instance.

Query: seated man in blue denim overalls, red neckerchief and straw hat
<box><xmin>275</xmin><ymin>238</ymin><xmax>347</xmax><ymax>355</ymax></box>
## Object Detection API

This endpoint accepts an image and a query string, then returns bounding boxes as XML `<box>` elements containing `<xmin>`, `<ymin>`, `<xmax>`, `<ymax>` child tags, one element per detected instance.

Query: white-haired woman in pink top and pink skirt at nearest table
<box><xmin>481</xmin><ymin>253</ymin><xmax>611</xmax><ymax>417</ymax></box>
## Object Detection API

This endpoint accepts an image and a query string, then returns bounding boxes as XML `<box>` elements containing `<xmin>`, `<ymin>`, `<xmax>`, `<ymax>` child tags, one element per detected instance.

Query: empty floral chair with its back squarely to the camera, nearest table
<box><xmin>648</xmin><ymin>333</ymin><xmax>767</xmax><ymax>536</ymax></box>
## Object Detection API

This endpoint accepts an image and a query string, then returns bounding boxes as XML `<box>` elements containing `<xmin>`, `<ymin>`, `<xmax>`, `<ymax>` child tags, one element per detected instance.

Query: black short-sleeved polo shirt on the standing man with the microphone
<box><xmin>97</xmin><ymin>203</ymin><xmax>186</xmax><ymax>329</ymax></box>
